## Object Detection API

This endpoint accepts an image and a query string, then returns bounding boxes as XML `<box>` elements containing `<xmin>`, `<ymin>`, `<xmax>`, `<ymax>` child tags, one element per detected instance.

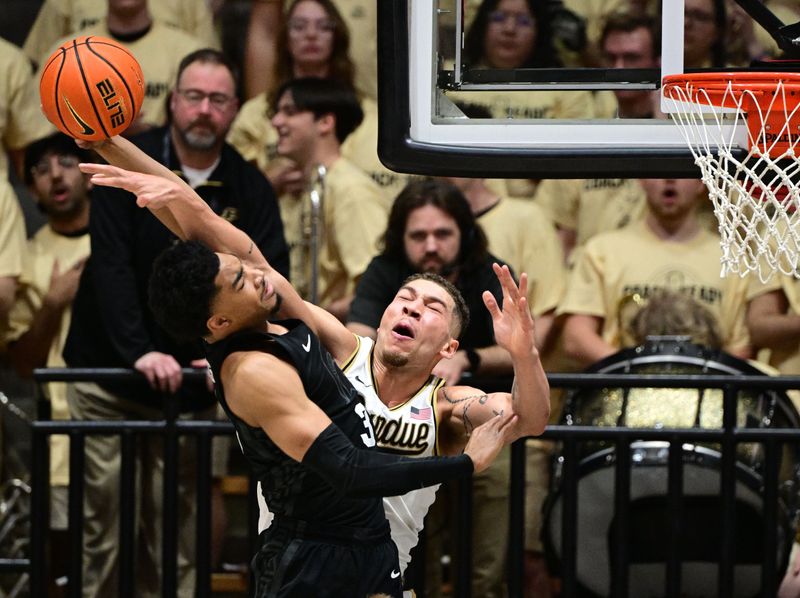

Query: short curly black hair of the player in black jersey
<box><xmin>148</xmin><ymin>241</ymin><xmax>220</xmax><ymax>341</ymax></box>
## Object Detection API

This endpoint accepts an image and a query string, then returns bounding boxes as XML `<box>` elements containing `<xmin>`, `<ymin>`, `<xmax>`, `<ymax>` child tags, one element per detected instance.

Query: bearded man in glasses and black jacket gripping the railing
<box><xmin>64</xmin><ymin>49</ymin><xmax>289</xmax><ymax>596</ymax></box>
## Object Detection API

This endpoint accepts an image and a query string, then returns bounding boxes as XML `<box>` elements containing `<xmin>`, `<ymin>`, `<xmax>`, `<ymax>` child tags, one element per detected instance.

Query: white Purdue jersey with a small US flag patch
<box><xmin>342</xmin><ymin>337</ymin><xmax>444</xmax><ymax>572</ymax></box>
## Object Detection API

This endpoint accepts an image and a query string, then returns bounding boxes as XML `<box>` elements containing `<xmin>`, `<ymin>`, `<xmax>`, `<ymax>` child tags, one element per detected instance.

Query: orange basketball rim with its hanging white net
<box><xmin>664</xmin><ymin>74</ymin><xmax>800</xmax><ymax>282</ymax></box>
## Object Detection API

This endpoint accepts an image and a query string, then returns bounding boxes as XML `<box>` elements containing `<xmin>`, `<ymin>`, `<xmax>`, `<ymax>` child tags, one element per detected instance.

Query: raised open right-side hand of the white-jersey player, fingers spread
<box><xmin>483</xmin><ymin>264</ymin><xmax>536</xmax><ymax>356</ymax></box>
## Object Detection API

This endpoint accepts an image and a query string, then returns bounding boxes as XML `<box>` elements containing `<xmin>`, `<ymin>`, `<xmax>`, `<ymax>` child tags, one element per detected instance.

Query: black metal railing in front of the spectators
<box><xmin>0</xmin><ymin>369</ymin><xmax>800</xmax><ymax>598</ymax></box>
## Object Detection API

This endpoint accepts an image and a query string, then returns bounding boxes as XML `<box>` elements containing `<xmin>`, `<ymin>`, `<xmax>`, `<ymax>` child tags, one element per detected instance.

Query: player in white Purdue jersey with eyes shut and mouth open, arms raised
<box><xmin>76</xmin><ymin>139</ymin><xmax>550</xmax><ymax>584</ymax></box>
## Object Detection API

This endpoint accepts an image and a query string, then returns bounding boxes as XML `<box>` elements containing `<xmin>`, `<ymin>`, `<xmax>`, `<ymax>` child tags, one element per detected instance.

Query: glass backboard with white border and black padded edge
<box><xmin>378</xmin><ymin>0</ymin><xmax>800</xmax><ymax>178</ymax></box>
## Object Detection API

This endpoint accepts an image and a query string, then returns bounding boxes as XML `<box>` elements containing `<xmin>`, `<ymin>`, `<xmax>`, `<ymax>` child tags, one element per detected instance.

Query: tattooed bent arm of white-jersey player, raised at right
<box><xmin>438</xmin><ymin>264</ymin><xmax>550</xmax><ymax>454</ymax></box>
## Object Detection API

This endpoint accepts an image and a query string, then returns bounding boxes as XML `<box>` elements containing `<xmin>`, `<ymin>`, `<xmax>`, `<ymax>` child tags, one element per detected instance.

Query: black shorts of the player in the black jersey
<box><xmin>252</xmin><ymin>519</ymin><xmax>403</xmax><ymax>598</ymax></box>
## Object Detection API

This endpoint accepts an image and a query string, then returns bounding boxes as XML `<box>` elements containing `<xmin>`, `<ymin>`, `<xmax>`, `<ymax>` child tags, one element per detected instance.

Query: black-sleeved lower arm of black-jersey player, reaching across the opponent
<box><xmin>222</xmin><ymin>352</ymin><xmax>516</xmax><ymax>496</ymax></box>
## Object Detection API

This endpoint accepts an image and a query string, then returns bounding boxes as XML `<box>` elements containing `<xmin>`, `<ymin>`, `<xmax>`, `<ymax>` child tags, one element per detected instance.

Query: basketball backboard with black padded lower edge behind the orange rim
<box><xmin>378</xmin><ymin>0</ymin><xmax>800</xmax><ymax>178</ymax></box>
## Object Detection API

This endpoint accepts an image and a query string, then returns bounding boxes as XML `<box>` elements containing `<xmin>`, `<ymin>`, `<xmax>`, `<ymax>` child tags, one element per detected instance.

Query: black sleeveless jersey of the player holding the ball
<box><xmin>206</xmin><ymin>320</ymin><xmax>386</xmax><ymax>529</ymax></box>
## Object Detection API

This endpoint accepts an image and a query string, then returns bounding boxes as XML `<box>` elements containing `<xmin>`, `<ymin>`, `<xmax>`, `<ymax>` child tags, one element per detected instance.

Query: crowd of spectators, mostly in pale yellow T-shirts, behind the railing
<box><xmin>0</xmin><ymin>0</ymin><xmax>800</xmax><ymax>596</ymax></box>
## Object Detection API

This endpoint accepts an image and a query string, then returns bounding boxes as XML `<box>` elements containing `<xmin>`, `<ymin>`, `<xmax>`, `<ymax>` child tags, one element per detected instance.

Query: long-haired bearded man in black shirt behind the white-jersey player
<box><xmin>347</xmin><ymin>180</ymin><xmax>512</xmax><ymax>384</ymax></box>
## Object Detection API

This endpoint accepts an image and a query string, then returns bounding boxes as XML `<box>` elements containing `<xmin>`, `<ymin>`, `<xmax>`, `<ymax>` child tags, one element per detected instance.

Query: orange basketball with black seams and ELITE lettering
<box><xmin>39</xmin><ymin>36</ymin><xmax>144</xmax><ymax>141</ymax></box>
